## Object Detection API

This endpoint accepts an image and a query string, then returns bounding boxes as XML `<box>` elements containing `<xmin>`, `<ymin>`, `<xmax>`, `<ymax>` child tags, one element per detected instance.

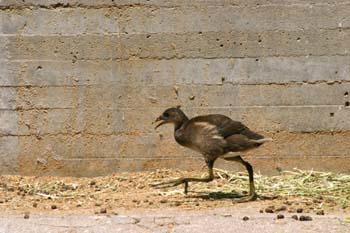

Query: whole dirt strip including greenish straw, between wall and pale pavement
<box><xmin>0</xmin><ymin>169</ymin><xmax>350</xmax><ymax>214</ymax></box>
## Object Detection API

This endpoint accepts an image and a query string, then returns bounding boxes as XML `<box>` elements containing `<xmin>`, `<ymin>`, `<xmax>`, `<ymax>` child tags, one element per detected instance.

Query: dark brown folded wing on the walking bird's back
<box><xmin>189</xmin><ymin>114</ymin><xmax>263</xmax><ymax>139</ymax></box>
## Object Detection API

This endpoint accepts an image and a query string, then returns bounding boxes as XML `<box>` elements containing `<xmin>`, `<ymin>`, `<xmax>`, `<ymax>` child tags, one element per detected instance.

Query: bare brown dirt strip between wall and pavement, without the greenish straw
<box><xmin>0</xmin><ymin>167</ymin><xmax>350</xmax><ymax>217</ymax></box>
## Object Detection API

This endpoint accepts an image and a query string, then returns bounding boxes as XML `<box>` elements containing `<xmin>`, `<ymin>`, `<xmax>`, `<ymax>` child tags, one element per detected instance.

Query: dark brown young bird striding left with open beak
<box><xmin>151</xmin><ymin>106</ymin><xmax>272</xmax><ymax>201</ymax></box>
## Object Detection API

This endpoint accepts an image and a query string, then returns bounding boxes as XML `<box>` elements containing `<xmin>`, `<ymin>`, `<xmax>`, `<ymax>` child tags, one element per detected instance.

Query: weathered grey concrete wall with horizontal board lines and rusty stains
<box><xmin>0</xmin><ymin>0</ymin><xmax>350</xmax><ymax>176</ymax></box>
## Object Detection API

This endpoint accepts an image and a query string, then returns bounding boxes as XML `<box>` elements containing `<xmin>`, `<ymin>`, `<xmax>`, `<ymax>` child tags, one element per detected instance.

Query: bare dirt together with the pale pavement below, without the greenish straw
<box><xmin>0</xmin><ymin>170</ymin><xmax>350</xmax><ymax>233</ymax></box>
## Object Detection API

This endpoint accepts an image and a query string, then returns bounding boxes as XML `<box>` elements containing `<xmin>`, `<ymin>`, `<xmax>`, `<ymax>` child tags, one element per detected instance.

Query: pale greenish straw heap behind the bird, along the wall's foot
<box><xmin>216</xmin><ymin>169</ymin><xmax>350</xmax><ymax>208</ymax></box>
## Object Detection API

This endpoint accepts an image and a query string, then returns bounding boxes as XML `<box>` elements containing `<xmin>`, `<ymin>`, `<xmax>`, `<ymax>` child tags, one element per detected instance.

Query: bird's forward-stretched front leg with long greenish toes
<box><xmin>150</xmin><ymin>161</ymin><xmax>214</xmax><ymax>194</ymax></box>
